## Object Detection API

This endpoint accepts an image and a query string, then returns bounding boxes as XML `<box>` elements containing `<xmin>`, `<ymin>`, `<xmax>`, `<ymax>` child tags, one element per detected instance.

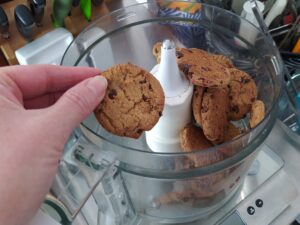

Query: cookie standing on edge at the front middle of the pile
<box><xmin>201</xmin><ymin>87</ymin><xmax>229</xmax><ymax>144</ymax></box>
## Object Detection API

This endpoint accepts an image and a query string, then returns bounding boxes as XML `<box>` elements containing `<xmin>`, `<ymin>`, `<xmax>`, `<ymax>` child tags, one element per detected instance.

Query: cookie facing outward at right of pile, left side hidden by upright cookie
<box><xmin>227</xmin><ymin>68</ymin><xmax>257</xmax><ymax>120</ymax></box>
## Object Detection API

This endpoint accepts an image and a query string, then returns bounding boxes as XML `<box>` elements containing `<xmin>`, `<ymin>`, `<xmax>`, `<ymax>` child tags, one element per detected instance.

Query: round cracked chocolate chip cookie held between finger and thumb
<box><xmin>94</xmin><ymin>63</ymin><xmax>165</xmax><ymax>138</ymax></box>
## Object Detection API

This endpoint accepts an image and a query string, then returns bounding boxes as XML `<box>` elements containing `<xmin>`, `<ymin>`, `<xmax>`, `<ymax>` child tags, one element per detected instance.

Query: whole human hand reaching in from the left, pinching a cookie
<box><xmin>0</xmin><ymin>65</ymin><xmax>107</xmax><ymax>225</ymax></box>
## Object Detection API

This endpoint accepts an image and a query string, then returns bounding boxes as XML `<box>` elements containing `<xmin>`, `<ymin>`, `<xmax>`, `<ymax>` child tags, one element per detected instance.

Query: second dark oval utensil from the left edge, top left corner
<box><xmin>14</xmin><ymin>4</ymin><xmax>36</xmax><ymax>41</ymax></box>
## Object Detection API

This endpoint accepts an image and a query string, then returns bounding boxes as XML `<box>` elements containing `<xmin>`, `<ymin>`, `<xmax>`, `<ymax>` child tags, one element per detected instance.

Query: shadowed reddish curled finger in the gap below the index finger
<box><xmin>24</xmin><ymin>91</ymin><xmax>65</xmax><ymax>109</ymax></box>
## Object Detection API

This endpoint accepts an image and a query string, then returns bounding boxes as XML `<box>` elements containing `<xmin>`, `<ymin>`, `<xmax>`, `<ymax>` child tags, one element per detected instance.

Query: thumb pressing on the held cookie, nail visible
<box><xmin>51</xmin><ymin>76</ymin><xmax>107</xmax><ymax>132</ymax></box>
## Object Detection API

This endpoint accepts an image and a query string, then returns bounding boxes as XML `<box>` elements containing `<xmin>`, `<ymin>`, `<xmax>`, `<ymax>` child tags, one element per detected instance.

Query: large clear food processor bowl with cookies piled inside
<box><xmin>54</xmin><ymin>1</ymin><xmax>283</xmax><ymax>224</ymax></box>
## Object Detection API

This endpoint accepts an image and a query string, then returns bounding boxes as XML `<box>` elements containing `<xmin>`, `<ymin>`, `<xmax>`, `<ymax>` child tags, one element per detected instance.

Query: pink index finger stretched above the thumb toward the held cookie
<box><xmin>1</xmin><ymin>65</ymin><xmax>100</xmax><ymax>100</ymax></box>
